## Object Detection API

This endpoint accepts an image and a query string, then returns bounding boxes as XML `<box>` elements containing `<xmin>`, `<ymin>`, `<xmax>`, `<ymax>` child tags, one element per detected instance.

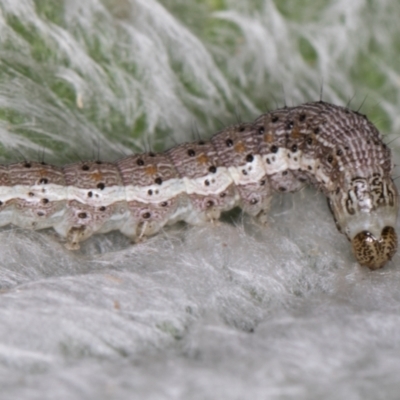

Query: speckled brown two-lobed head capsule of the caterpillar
<box><xmin>351</xmin><ymin>226</ymin><xmax>397</xmax><ymax>269</ymax></box>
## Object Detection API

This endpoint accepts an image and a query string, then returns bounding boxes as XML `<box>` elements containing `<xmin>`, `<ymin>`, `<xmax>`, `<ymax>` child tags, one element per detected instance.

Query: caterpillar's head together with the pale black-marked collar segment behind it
<box><xmin>328</xmin><ymin>173</ymin><xmax>399</xmax><ymax>269</ymax></box>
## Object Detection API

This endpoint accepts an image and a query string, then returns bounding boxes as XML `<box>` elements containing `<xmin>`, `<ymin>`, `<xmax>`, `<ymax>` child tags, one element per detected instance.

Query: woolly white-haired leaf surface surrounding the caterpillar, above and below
<box><xmin>0</xmin><ymin>0</ymin><xmax>400</xmax><ymax>400</ymax></box>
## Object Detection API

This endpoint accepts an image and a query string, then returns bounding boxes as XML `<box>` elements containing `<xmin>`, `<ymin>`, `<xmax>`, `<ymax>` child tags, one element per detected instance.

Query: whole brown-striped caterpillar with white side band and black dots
<box><xmin>0</xmin><ymin>101</ymin><xmax>398</xmax><ymax>269</ymax></box>
